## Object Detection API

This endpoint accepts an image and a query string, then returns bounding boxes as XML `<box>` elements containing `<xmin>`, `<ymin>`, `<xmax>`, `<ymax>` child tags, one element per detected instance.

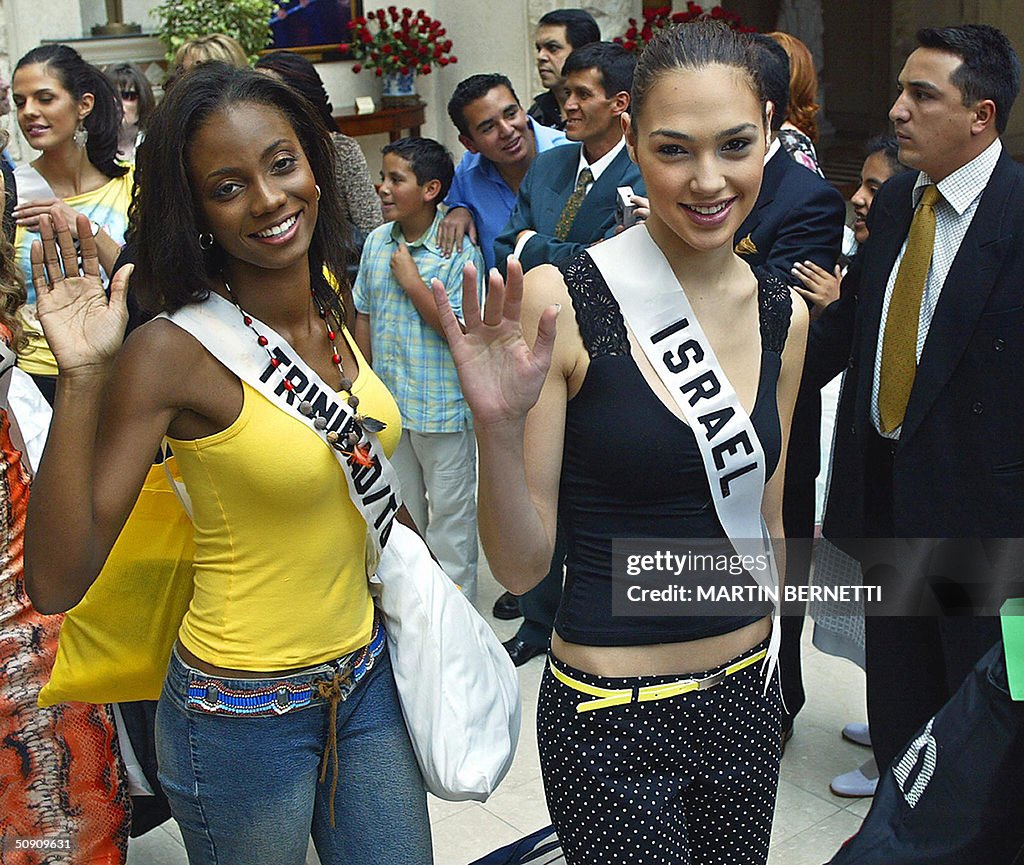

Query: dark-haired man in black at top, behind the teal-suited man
<box><xmin>527</xmin><ymin>9</ymin><xmax>601</xmax><ymax>129</ymax></box>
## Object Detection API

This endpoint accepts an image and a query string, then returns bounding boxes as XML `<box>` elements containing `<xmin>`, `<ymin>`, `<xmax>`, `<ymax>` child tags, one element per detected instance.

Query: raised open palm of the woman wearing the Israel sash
<box><xmin>433</xmin><ymin>259</ymin><xmax>558</xmax><ymax>426</ymax></box>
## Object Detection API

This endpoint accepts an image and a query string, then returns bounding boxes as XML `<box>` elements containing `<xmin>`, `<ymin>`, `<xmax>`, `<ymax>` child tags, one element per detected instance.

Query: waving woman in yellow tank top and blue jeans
<box><xmin>26</xmin><ymin>64</ymin><xmax>431</xmax><ymax>865</ymax></box>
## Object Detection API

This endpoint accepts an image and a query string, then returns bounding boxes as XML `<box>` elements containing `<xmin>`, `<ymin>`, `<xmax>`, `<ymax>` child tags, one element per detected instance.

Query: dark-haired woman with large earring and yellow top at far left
<box><xmin>12</xmin><ymin>45</ymin><xmax>133</xmax><ymax>402</ymax></box>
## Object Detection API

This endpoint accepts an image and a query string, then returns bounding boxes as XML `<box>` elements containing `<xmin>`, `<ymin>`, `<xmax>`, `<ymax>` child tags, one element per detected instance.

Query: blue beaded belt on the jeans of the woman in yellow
<box><xmin>185</xmin><ymin>620</ymin><xmax>386</xmax><ymax>718</ymax></box>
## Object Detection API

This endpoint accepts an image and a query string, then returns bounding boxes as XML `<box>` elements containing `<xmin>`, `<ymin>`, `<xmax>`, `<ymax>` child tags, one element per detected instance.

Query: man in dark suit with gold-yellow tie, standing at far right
<box><xmin>807</xmin><ymin>25</ymin><xmax>1024</xmax><ymax>771</ymax></box>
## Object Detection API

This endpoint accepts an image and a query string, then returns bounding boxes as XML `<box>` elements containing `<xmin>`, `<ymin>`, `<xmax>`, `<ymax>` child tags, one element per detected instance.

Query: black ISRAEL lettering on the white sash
<box><xmin>650</xmin><ymin>317</ymin><xmax>758</xmax><ymax>499</ymax></box>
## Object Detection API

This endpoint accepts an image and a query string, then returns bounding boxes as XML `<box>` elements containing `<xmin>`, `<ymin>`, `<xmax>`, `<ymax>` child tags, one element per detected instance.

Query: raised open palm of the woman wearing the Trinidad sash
<box><xmin>32</xmin><ymin>209</ymin><xmax>131</xmax><ymax>374</ymax></box>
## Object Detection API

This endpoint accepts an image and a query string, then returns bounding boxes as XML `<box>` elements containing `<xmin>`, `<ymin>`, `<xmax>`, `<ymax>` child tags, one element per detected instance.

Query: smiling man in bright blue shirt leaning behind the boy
<box><xmin>437</xmin><ymin>73</ymin><xmax>568</xmax><ymax>269</ymax></box>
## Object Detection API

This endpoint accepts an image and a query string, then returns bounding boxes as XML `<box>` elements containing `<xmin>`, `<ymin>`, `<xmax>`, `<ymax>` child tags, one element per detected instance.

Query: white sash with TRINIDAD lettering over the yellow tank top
<box><xmin>159</xmin><ymin>292</ymin><xmax>402</xmax><ymax>555</ymax></box>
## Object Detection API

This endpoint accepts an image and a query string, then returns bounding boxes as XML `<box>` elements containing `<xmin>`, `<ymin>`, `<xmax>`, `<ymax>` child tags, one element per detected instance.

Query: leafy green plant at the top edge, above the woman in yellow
<box><xmin>151</xmin><ymin>0</ymin><xmax>278</xmax><ymax>61</ymax></box>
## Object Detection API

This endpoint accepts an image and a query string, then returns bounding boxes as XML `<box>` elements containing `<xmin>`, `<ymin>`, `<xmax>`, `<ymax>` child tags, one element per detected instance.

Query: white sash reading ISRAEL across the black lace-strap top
<box><xmin>587</xmin><ymin>224</ymin><xmax>781</xmax><ymax>690</ymax></box>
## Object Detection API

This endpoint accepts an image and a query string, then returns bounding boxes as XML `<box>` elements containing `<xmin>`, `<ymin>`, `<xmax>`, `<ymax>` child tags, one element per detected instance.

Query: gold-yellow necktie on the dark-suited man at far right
<box><xmin>879</xmin><ymin>183</ymin><xmax>942</xmax><ymax>432</ymax></box>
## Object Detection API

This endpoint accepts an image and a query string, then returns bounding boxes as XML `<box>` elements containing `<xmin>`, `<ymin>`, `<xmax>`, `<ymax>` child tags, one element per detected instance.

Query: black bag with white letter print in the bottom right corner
<box><xmin>829</xmin><ymin>642</ymin><xmax>1024</xmax><ymax>865</ymax></box>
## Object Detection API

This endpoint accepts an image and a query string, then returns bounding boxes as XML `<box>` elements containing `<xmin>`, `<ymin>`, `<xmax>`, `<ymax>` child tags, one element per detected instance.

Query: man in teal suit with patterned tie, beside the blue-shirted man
<box><xmin>495</xmin><ymin>42</ymin><xmax>643</xmax><ymax>270</ymax></box>
